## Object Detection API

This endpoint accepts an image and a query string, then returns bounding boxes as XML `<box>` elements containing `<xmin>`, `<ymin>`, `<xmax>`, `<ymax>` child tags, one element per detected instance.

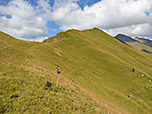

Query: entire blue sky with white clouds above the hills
<box><xmin>0</xmin><ymin>0</ymin><xmax>152</xmax><ymax>41</ymax></box>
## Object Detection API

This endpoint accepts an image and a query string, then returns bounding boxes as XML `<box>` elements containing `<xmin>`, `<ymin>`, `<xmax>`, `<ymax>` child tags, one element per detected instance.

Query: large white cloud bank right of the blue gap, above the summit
<box><xmin>51</xmin><ymin>0</ymin><xmax>152</xmax><ymax>36</ymax></box>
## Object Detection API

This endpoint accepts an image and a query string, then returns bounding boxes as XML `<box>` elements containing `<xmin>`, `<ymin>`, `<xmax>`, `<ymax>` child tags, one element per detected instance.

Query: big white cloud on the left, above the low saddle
<box><xmin>0</xmin><ymin>0</ymin><xmax>48</xmax><ymax>38</ymax></box>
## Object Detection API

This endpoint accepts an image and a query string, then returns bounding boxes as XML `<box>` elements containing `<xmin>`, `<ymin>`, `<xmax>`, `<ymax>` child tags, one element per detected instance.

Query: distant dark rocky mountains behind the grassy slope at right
<box><xmin>115</xmin><ymin>34</ymin><xmax>152</xmax><ymax>54</ymax></box>
